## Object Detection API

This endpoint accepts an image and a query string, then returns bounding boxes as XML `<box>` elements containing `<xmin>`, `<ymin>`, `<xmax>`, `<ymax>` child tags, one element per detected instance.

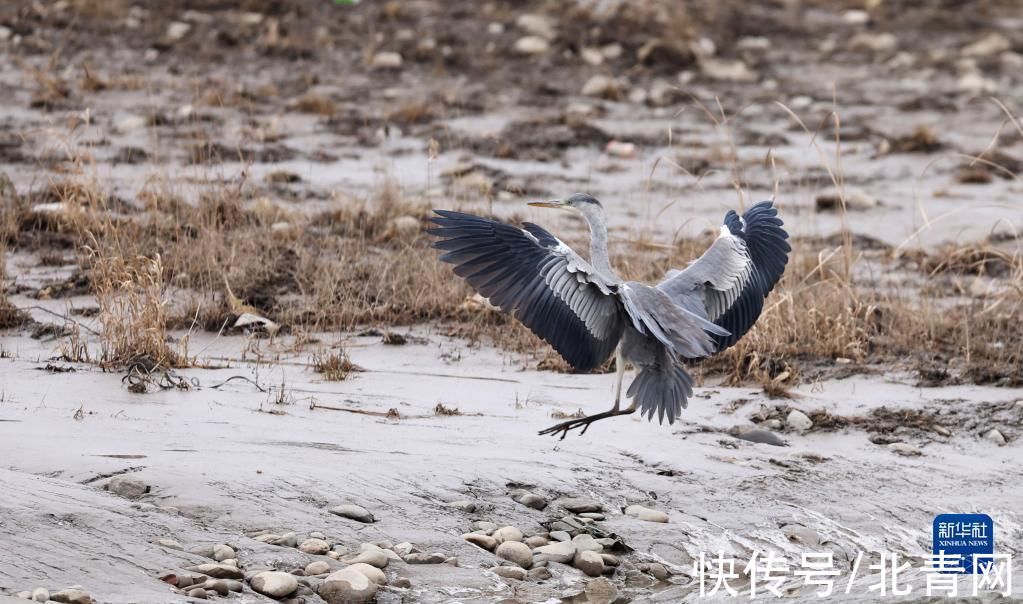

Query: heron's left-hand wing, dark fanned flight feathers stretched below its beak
<box><xmin>430</xmin><ymin>210</ymin><xmax>624</xmax><ymax>371</ymax></box>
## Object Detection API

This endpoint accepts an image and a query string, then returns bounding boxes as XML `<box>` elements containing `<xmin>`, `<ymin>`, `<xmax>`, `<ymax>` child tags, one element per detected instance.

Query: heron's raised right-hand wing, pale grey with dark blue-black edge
<box><xmin>657</xmin><ymin>202</ymin><xmax>792</xmax><ymax>351</ymax></box>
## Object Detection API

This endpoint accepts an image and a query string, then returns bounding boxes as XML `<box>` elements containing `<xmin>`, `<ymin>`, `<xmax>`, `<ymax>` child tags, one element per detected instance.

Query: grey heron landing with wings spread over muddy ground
<box><xmin>430</xmin><ymin>193</ymin><xmax>792</xmax><ymax>439</ymax></box>
